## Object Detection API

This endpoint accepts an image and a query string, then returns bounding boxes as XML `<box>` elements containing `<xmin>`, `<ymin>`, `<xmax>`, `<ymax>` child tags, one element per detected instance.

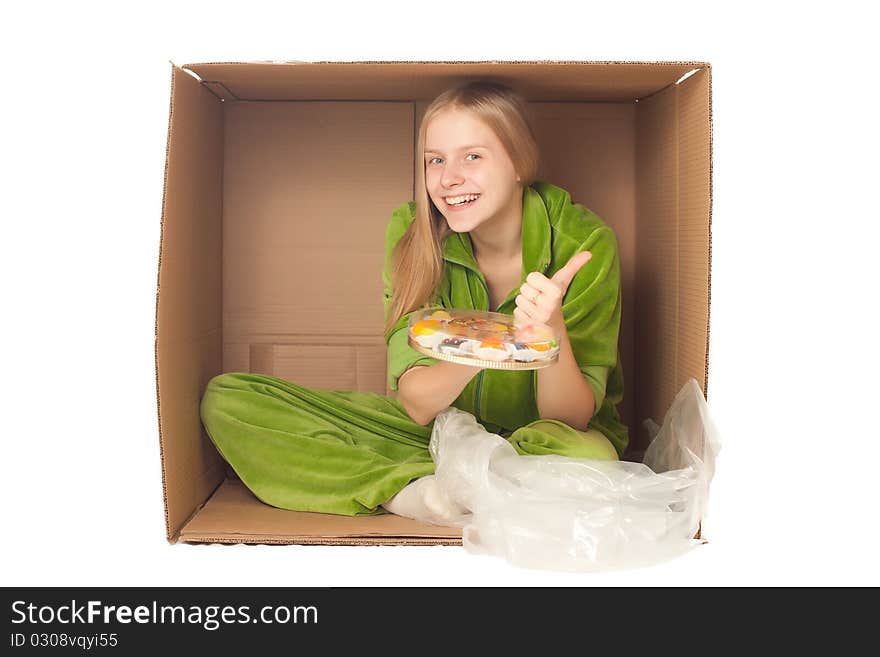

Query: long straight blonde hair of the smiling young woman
<box><xmin>385</xmin><ymin>81</ymin><xmax>540</xmax><ymax>337</ymax></box>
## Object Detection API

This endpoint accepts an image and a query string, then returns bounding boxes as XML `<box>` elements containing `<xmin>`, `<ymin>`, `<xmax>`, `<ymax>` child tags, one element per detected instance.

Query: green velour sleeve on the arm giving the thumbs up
<box><xmin>562</xmin><ymin>225</ymin><xmax>621</xmax><ymax>411</ymax></box>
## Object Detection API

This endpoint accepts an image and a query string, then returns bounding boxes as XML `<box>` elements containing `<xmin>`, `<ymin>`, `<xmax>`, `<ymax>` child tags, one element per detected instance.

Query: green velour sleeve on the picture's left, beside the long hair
<box><xmin>382</xmin><ymin>202</ymin><xmax>440</xmax><ymax>392</ymax></box>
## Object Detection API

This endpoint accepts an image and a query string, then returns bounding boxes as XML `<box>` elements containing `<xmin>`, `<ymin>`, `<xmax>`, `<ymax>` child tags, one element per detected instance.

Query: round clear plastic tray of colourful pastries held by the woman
<box><xmin>409</xmin><ymin>308</ymin><xmax>559</xmax><ymax>370</ymax></box>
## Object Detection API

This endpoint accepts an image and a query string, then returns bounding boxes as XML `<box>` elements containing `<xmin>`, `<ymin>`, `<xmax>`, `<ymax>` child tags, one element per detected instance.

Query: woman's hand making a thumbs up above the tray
<box><xmin>513</xmin><ymin>251</ymin><xmax>593</xmax><ymax>332</ymax></box>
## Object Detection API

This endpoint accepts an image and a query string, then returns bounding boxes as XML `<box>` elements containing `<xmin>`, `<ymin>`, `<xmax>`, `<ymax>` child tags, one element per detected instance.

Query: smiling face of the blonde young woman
<box><xmin>425</xmin><ymin>108</ymin><xmax>522</xmax><ymax>233</ymax></box>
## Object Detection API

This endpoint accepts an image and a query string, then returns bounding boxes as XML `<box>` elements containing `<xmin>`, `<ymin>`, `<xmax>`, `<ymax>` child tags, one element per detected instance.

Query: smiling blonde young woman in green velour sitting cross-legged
<box><xmin>201</xmin><ymin>82</ymin><xmax>628</xmax><ymax>517</ymax></box>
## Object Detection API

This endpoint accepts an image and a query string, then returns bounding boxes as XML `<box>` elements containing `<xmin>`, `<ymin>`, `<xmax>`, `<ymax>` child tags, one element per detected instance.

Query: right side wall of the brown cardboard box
<box><xmin>635</xmin><ymin>66</ymin><xmax>712</xmax><ymax>423</ymax></box>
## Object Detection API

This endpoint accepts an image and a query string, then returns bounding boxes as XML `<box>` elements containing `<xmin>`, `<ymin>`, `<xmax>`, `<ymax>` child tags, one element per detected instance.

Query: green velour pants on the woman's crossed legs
<box><xmin>200</xmin><ymin>373</ymin><xmax>617</xmax><ymax>516</ymax></box>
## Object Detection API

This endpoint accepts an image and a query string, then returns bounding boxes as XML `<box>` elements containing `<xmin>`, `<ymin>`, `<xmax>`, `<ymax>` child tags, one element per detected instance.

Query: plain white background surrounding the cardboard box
<box><xmin>0</xmin><ymin>0</ymin><xmax>880</xmax><ymax>586</ymax></box>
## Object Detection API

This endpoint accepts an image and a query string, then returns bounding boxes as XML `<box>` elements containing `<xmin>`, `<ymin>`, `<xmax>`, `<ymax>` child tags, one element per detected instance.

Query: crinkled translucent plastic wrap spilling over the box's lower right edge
<box><xmin>419</xmin><ymin>379</ymin><xmax>720</xmax><ymax>571</ymax></box>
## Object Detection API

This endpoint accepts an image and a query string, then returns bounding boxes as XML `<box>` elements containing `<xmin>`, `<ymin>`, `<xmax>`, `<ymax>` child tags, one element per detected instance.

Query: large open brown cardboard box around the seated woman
<box><xmin>156</xmin><ymin>62</ymin><xmax>712</xmax><ymax>545</ymax></box>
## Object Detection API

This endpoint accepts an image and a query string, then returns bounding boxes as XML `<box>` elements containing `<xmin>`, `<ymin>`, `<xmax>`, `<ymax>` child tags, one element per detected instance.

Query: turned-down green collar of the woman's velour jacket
<box><xmin>443</xmin><ymin>187</ymin><xmax>550</xmax><ymax>282</ymax></box>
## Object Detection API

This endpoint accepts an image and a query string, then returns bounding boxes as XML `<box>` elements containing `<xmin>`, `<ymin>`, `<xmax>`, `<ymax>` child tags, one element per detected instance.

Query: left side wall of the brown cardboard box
<box><xmin>156</xmin><ymin>62</ymin><xmax>224</xmax><ymax>541</ymax></box>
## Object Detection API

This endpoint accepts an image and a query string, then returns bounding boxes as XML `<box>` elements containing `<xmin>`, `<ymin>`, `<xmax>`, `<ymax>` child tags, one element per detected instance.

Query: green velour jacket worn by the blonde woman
<box><xmin>383</xmin><ymin>181</ymin><xmax>629</xmax><ymax>457</ymax></box>
